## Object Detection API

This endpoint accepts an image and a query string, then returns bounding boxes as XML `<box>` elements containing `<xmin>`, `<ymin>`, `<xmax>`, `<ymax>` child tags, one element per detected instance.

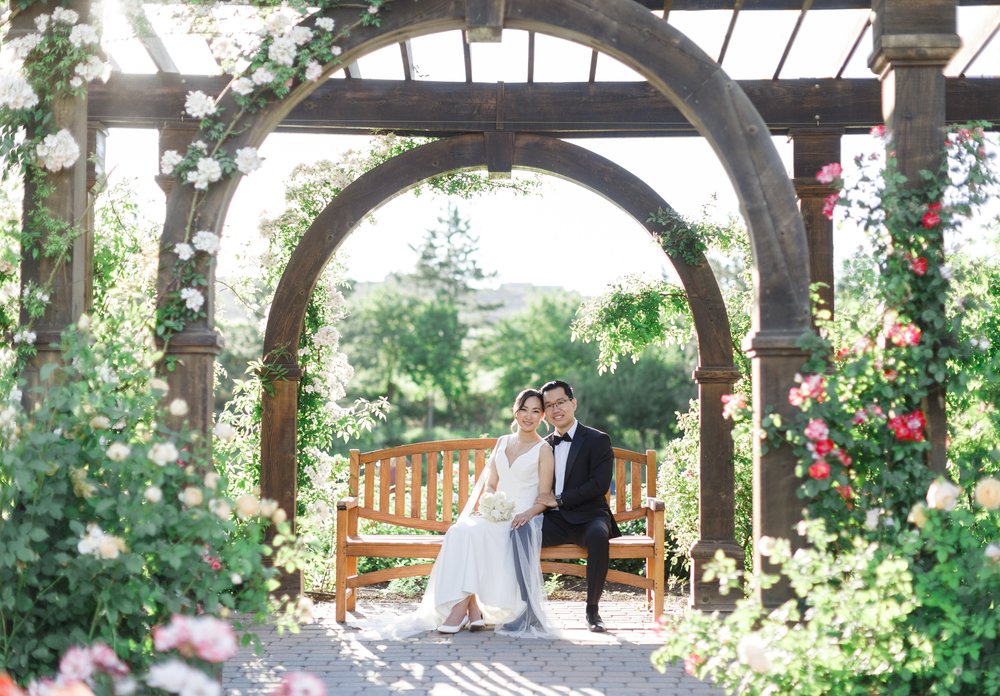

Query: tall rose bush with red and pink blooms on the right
<box><xmin>656</xmin><ymin>127</ymin><xmax>1000</xmax><ymax>694</ymax></box>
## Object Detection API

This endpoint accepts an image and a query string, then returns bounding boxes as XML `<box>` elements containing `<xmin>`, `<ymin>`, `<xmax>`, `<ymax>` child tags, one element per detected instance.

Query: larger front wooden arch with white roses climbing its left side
<box><xmin>158</xmin><ymin>0</ymin><xmax>810</xmax><ymax>601</ymax></box>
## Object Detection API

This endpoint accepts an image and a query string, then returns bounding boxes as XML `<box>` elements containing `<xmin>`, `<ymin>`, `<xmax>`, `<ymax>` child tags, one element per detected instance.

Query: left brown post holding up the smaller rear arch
<box><xmin>260</xmin><ymin>364</ymin><xmax>302</xmax><ymax>596</ymax></box>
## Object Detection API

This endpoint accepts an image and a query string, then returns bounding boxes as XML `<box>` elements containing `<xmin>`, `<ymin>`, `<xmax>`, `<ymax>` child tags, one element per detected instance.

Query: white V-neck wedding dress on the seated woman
<box><xmin>355</xmin><ymin>435</ymin><xmax>557</xmax><ymax>639</ymax></box>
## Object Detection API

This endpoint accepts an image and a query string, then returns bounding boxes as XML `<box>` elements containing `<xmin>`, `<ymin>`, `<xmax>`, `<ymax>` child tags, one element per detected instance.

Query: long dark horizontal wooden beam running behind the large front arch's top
<box><xmin>89</xmin><ymin>74</ymin><xmax>1000</xmax><ymax>137</ymax></box>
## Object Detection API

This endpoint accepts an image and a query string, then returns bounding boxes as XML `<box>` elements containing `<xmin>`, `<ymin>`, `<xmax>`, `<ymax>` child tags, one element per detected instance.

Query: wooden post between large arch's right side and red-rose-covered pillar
<box><xmin>789</xmin><ymin>128</ymin><xmax>844</xmax><ymax>322</ymax></box>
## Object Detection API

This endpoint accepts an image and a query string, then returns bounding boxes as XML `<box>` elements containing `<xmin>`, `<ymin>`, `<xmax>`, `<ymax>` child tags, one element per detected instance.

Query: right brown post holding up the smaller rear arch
<box><xmin>690</xmin><ymin>367</ymin><xmax>744</xmax><ymax>611</ymax></box>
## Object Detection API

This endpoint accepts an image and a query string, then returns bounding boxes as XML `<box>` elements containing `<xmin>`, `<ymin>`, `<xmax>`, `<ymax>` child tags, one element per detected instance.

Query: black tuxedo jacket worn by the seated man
<box><xmin>546</xmin><ymin>423</ymin><xmax>622</xmax><ymax>538</ymax></box>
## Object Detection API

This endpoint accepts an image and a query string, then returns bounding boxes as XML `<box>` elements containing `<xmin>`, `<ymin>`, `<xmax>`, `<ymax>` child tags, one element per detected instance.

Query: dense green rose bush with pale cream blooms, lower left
<box><xmin>0</xmin><ymin>306</ymin><xmax>284</xmax><ymax>678</ymax></box>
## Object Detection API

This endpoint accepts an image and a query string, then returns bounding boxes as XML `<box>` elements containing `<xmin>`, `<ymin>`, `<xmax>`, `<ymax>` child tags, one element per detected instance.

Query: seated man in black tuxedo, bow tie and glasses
<box><xmin>514</xmin><ymin>380</ymin><xmax>621</xmax><ymax>633</ymax></box>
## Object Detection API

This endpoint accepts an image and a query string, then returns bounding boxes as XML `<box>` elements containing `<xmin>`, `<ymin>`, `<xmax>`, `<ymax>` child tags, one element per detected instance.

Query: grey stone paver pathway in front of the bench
<box><xmin>223</xmin><ymin>601</ymin><xmax>721</xmax><ymax>696</ymax></box>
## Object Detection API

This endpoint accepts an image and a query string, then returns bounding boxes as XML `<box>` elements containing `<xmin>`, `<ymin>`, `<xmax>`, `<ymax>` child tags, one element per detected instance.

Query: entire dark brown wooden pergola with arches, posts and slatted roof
<box><xmin>15</xmin><ymin>0</ymin><xmax>1000</xmax><ymax>609</ymax></box>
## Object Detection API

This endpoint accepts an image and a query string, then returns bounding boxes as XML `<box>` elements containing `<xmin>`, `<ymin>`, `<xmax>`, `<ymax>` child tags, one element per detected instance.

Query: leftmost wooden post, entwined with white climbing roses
<box><xmin>14</xmin><ymin>0</ymin><xmax>90</xmax><ymax>411</ymax></box>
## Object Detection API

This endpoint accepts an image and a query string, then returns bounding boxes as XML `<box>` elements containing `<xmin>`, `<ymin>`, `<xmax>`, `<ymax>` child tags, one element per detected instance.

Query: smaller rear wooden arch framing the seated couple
<box><xmin>261</xmin><ymin>133</ymin><xmax>742</xmax><ymax>608</ymax></box>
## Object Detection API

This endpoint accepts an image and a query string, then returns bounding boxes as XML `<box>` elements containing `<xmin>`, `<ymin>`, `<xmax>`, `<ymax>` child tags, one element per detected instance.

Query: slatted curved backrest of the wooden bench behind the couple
<box><xmin>348</xmin><ymin>438</ymin><xmax>656</xmax><ymax>531</ymax></box>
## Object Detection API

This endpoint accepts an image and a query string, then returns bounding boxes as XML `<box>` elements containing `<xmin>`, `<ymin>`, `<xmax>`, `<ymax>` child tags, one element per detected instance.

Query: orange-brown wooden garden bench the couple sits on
<box><xmin>336</xmin><ymin>438</ymin><xmax>664</xmax><ymax>622</ymax></box>
